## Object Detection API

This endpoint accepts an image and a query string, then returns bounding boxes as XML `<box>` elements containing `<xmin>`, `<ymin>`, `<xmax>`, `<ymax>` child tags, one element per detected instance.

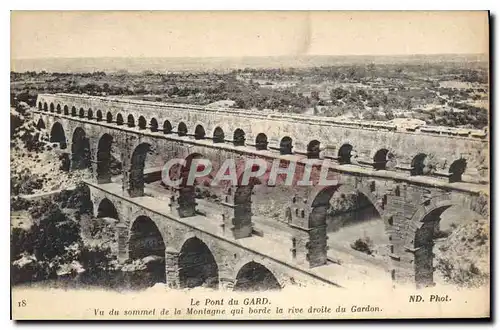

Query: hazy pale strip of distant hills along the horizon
<box><xmin>11</xmin><ymin>54</ymin><xmax>488</xmax><ymax>73</ymax></box>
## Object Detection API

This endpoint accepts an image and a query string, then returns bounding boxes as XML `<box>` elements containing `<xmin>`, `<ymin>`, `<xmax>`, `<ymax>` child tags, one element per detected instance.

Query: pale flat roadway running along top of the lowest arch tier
<box><xmin>85</xmin><ymin>181</ymin><xmax>393</xmax><ymax>289</ymax></box>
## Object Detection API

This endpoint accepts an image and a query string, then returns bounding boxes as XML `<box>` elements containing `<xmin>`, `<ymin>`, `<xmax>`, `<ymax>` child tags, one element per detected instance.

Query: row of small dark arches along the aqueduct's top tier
<box><xmin>34</xmin><ymin>101</ymin><xmax>476</xmax><ymax>182</ymax></box>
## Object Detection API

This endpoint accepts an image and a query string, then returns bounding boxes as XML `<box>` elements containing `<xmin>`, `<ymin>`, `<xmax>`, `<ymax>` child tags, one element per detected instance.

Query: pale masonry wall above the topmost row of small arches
<box><xmin>37</xmin><ymin>94</ymin><xmax>489</xmax><ymax>180</ymax></box>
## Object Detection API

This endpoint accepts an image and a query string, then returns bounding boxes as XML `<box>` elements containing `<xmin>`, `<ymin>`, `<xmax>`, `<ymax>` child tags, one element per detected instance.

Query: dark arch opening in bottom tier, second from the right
<box><xmin>178</xmin><ymin>237</ymin><xmax>219</xmax><ymax>289</ymax></box>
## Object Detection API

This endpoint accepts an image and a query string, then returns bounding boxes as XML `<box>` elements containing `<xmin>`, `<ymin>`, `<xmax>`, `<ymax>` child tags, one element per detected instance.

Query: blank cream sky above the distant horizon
<box><xmin>11</xmin><ymin>11</ymin><xmax>489</xmax><ymax>59</ymax></box>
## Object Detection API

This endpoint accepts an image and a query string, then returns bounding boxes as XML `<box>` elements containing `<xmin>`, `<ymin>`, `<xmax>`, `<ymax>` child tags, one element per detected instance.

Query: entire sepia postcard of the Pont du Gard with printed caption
<box><xmin>10</xmin><ymin>11</ymin><xmax>491</xmax><ymax>320</ymax></box>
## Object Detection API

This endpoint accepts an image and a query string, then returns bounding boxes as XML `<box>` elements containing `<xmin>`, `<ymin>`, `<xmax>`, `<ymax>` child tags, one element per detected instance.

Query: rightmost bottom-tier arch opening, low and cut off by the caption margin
<box><xmin>233</xmin><ymin>261</ymin><xmax>282</xmax><ymax>292</ymax></box>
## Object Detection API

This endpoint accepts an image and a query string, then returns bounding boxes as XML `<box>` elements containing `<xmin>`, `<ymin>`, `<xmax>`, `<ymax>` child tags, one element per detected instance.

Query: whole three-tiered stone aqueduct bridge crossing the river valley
<box><xmin>33</xmin><ymin>94</ymin><xmax>489</xmax><ymax>287</ymax></box>
